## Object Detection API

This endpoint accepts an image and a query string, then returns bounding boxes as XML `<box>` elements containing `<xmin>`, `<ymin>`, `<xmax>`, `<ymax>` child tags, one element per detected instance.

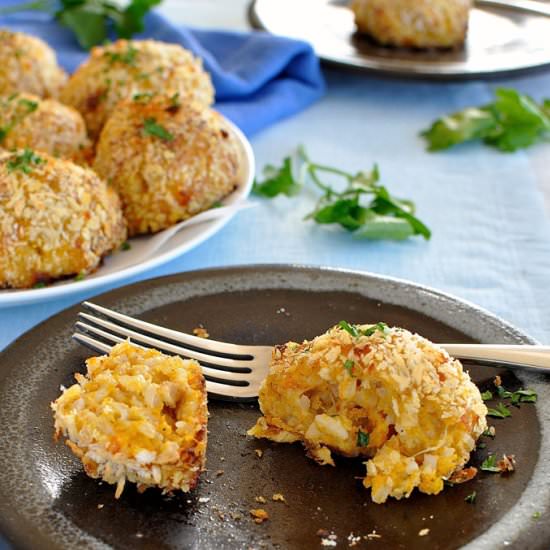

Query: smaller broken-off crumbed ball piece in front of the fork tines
<box><xmin>52</xmin><ymin>342</ymin><xmax>208</xmax><ymax>498</ymax></box>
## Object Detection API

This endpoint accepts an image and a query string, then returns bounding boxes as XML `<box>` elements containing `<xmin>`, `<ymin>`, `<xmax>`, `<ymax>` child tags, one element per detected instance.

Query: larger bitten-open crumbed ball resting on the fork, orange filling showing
<box><xmin>248</xmin><ymin>325</ymin><xmax>487</xmax><ymax>503</ymax></box>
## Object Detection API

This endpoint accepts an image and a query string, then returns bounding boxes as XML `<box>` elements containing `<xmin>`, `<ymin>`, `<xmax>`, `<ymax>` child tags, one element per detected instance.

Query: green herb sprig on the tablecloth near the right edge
<box><xmin>421</xmin><ymin>88</ymin><xmax>550</xmax><ymax>152</ymax></box>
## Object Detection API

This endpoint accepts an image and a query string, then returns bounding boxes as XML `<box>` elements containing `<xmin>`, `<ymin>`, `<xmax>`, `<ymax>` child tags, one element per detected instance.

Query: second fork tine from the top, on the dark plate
<box><xmin>76</xmin><ymin>312</ymin><xmax>253</xmax><ymax>373</ymax></box>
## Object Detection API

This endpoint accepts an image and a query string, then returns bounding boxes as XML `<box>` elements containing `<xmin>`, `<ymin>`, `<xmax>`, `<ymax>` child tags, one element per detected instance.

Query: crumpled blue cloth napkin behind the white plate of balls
<box><xmin>0</xmin><ymin>8</ymin><xmax>324</xmax><ymax>135</ymax></box>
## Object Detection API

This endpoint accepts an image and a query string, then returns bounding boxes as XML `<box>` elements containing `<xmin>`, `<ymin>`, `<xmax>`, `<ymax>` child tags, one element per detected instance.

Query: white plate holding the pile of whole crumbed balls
<box><xmin>0</xmin><ymin>119</ymin><xmax>255</xmax><ymax>308</ymax></box>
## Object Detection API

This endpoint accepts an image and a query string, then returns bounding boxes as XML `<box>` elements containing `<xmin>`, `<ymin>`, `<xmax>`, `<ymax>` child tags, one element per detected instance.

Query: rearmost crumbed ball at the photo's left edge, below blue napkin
<box><xmin>0</xmin><ymin>29</ymin><xmax>67</xmax><ymax>98</ymax></box>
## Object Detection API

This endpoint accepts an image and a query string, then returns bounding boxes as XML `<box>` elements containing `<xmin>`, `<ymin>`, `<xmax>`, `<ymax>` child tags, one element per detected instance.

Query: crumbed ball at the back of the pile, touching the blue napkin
<box><xmin>61</xmin><ymin>40</ymin><xmax>214</xmax><ymax>139</ymax></box>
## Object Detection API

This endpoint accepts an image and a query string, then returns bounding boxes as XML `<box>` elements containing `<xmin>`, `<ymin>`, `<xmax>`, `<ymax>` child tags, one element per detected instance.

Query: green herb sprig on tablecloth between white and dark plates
<box><xmin>253</xmin><ymin>147</ymin><xmax>431</xmax><ymax>240</ymax></box>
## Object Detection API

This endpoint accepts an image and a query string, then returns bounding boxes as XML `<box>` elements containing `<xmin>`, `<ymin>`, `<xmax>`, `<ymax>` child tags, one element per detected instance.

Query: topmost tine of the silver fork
<box><xmin>82</xmin><ymin>302</ymin><xmax>254</xmax><ymax>358</ymax></box>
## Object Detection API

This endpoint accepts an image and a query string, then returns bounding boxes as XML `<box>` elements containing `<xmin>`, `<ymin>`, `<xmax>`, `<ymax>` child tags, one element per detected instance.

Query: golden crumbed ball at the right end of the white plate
<box><xmin>94</xmin><ymin>95</ymin><xmax>240</xmax><ymax>236</ymax></box>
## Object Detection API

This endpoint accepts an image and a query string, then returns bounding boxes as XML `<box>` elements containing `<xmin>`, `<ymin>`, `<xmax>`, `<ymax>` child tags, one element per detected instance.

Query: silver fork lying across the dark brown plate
<box><xmin>73</xmin><ymin>302</ymin><xmax>550</xmax><ymax>399</ymax></box>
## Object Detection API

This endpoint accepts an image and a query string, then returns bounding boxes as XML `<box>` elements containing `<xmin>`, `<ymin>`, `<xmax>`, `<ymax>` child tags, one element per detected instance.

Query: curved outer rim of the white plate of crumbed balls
<box><xmin>0</xmin><ymin>115</ymin><xmax>256</xmax><ymax>309</ymax></box>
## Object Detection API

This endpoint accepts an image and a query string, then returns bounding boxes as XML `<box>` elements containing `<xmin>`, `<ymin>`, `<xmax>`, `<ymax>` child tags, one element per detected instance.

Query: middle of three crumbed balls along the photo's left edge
<box><xmin>0</xmin><ymin>93</ymin><xmax>90</xmax><ymax>164</ymax></box>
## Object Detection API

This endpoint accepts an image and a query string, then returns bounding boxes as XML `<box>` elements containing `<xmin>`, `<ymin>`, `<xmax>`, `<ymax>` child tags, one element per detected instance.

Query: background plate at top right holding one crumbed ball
<box><xmin>250</xmin><ymin>0</ymin><xmax>550</xmax><ymax>79</ymax></box>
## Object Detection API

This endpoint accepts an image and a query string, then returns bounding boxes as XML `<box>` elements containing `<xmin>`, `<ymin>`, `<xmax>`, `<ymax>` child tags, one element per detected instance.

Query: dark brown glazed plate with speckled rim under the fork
<box><xmin>0</xmin><ymin>266</ymin><xmax>550</xmax><ymax>549</ymax></box>
